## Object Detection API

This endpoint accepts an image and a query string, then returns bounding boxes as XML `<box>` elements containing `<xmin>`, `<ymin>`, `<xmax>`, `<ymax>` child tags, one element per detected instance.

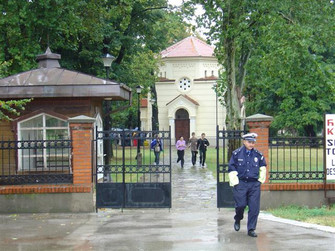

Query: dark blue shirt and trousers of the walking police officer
<box><xmin>228</xmin><ymin>146</ymin><xmax>266</xmax><ymax>231</ymax></box>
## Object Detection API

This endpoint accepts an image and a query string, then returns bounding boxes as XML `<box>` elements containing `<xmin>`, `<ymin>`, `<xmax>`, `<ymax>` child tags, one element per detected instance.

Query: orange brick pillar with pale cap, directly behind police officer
<box><xmin>246</xmin><ymin>114</ymin><xmax>273</xmax><ymax>183</ymax></box>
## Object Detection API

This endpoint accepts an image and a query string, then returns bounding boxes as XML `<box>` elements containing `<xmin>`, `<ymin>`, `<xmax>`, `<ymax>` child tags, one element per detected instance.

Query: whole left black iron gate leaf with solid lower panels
<box><xmin>95</xmin><ymin>130</ymin><xmax>171</xmax><ymax>209</ymax></box>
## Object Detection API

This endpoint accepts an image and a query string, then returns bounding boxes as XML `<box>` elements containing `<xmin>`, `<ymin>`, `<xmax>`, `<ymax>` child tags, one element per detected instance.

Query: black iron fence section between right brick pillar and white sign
<box><xmin>269</xmin><ymin>137</ymin><xmax>324</xmax><ymax>182</ymax></box>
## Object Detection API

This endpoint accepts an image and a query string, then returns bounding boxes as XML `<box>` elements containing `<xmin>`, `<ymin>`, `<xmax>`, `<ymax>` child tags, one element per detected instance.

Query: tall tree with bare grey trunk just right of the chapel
<box><xmin>195</xmin><ymin>0</ymin><xmax>261</xmax><ymax>130</ymax></box>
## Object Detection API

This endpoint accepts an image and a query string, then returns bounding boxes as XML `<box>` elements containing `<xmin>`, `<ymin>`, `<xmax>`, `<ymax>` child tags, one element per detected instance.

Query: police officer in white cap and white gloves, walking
<box><xmin>228</xmin><ymin>133</ymin><xmax>266</xmax><ymax>237</ymax></box>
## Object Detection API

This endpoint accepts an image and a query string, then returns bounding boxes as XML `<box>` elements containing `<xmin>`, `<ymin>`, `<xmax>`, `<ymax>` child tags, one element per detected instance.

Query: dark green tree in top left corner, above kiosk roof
<box><xmin>0</xmin><ymin>0</ymin><xmax>85</xmax><ymax>74</ymax></box>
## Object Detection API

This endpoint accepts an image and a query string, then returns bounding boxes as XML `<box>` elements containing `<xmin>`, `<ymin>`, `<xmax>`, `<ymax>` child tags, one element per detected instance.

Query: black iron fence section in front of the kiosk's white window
<box><xmin>0</xmin><ymin>139</ymin><xmax>73</xmax><ymax>185</ymax></box>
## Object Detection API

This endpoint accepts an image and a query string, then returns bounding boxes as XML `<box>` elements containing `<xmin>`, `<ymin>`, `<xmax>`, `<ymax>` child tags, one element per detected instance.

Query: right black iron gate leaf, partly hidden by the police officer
<box><xmin>216</xmin><ymin>127</ymin><xmax>246</xmax><ymax>208</ymax></box>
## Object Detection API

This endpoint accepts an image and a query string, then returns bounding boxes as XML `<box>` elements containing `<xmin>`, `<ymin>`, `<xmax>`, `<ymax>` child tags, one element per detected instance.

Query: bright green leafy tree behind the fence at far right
<box><xmin>245</xmin><ymin>1</ymin><xmax>335</xmax><ymax>136</ymax></box>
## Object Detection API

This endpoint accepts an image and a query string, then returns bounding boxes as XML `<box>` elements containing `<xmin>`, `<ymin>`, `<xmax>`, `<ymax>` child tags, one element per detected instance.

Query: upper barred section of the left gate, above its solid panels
<box><xmin>95</xmin><ymin>130</ymin><xmax>171</xmax><ymax>183</ymax></box>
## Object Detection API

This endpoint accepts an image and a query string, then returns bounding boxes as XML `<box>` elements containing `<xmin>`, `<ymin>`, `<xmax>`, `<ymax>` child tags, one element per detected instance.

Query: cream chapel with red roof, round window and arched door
<box><xmin>141</xmin><ymin>36</ymin><xmax>226</xmax><ymax>146</ymax></box>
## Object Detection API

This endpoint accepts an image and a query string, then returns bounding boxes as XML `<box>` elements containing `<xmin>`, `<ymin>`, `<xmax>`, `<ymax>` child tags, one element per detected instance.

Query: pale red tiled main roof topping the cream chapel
<box><xmin>161</xmin><ymin>36</ymin><xmax>214</xmax><ymax>58</ymax></box>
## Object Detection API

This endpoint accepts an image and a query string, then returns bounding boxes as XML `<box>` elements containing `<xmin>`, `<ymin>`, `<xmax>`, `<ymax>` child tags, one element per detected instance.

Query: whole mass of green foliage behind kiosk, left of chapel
<box><xmin>0</xmin><ymin>0</ymin><xmax>189</xmax><ymax>127</ymax></box>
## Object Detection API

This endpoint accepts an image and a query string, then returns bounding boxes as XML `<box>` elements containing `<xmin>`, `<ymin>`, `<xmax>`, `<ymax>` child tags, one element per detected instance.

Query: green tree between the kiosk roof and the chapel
<box><xmin>98</xmin><ymin>0</ymin><xmax>189</xmax><ymax>128</ymax></box>
